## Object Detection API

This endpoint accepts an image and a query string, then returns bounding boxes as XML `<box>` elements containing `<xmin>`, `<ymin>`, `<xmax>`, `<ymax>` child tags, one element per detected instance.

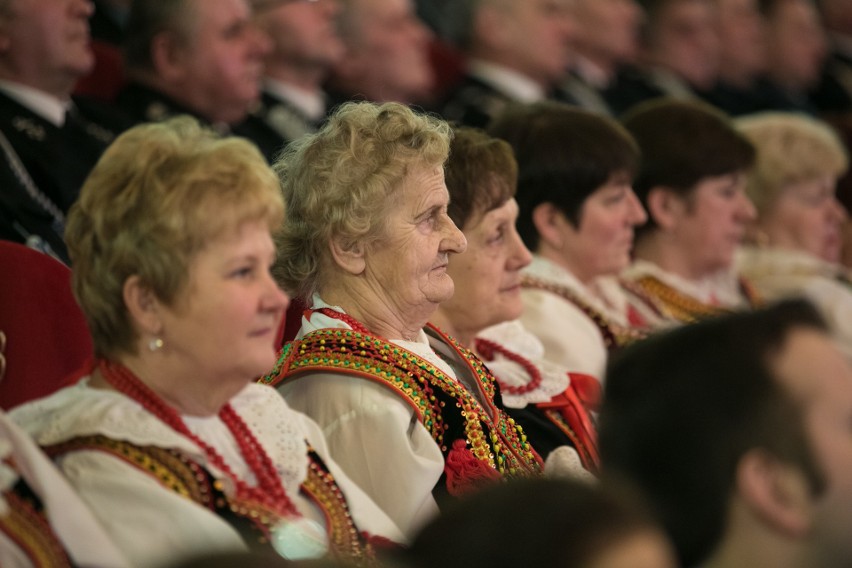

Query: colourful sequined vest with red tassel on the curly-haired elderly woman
<box><xmin>261</xmin><ymin>319</ymin><xmax>542</xmax><ymax>503</ymax></box>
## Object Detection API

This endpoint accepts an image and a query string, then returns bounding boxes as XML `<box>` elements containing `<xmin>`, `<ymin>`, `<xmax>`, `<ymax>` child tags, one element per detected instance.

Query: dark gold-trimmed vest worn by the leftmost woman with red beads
<box><xmin>43</xmin><ymin>435</ymin><xmax>388</xmax><ymax>565</ymax></box>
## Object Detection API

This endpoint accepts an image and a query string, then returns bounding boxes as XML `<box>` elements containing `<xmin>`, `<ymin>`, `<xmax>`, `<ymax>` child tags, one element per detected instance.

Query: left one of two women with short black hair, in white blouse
<box><xmin>490</xmin><ymin>103</ymin><xmax>657</xmax><ymax>381</ymax></box>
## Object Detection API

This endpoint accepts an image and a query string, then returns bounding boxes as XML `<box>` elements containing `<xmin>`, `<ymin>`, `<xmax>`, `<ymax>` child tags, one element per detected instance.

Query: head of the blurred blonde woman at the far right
<box><xmin>736</xmin><ymin>112</ymin><xmax>849</xmax><ymax>262</ymax></box>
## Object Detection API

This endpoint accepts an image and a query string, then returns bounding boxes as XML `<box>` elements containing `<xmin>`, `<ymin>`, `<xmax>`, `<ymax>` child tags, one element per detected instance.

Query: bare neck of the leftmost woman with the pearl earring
<box><xmin>100</xmin><ymin>346</ymin><xmax>248</xmax><ymax>416</ymax></box>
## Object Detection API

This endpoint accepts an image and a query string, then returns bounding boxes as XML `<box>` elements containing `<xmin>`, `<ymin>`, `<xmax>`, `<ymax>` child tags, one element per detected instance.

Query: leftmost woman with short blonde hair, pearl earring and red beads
<box><xmin>12</xmin><ymin>118</ymin><xmax>401</xmax><ymax>566</ymax></box>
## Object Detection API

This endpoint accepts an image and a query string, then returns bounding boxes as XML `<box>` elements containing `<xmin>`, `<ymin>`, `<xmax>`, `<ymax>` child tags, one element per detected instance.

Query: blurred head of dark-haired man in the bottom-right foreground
<box><xmin>600</xmin><ymin>300</ymin><xmax>852</xmax><ymax>568</ymax></box>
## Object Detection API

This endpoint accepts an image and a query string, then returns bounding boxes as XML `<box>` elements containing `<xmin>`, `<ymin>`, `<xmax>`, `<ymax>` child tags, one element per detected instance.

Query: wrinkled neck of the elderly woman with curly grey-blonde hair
<box><xmin>320</xmin><ymin>279</ymin><xmax>436</xmax><ymax>341</ymax></box>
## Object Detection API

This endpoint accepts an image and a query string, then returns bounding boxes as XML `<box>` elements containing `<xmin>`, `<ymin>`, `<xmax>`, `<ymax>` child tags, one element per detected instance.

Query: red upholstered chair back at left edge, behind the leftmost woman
<box><xmin>0</xmin><ymin>241</ymin><xmax>93</xmax><ymax>410</ymax></box>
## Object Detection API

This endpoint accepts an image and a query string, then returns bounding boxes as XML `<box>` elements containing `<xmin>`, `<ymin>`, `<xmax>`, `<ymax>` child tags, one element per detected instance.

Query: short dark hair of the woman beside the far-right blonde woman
<box><xmin>621</xmin><ymin>98</ymin><xmax>755</xmax><ymax>234</ymax></box>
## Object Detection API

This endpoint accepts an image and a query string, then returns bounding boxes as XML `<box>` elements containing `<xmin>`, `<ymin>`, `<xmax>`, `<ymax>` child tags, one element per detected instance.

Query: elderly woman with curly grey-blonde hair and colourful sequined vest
<box><xmin>265</xmin><ymin>103</ymin><xmax>541</xmax><ymax>535</ymax></box>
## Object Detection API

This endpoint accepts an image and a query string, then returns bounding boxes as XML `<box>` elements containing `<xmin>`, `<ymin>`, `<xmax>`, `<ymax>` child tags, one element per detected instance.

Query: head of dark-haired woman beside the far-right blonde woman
<box><xmin>622</xmin><ymin>98</ymin><xmax>754</xmax><ymax>280</ymax></box>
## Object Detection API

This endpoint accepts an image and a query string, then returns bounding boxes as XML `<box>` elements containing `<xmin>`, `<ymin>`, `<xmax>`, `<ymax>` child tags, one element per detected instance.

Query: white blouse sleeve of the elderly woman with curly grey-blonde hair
<box><xmin>279</xmin><ymin>373</ymin><xmax>444</xmax><ymax>539</ymax></box>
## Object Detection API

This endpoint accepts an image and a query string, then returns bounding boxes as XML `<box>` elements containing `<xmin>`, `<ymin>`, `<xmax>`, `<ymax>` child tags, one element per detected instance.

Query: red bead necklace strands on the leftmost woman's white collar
<box><xmin>97</xmin><ymin>359</ymin><xmax>301</xmax><ymax>528</ymax></box>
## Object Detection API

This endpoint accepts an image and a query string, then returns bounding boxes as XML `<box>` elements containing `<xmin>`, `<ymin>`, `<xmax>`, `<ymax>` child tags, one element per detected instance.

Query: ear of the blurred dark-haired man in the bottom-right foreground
<box><xmin>736</xmin><ymin>449</ymin><xmax>814</xmax><ymax>539</ymax></box>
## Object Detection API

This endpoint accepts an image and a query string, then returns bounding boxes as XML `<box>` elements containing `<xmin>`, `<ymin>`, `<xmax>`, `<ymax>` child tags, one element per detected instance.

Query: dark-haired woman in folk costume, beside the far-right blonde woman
<box><xmin>622</xmin><ymin>99</ymin><xmax>758</xmax><ymax>323</ymax></box>
